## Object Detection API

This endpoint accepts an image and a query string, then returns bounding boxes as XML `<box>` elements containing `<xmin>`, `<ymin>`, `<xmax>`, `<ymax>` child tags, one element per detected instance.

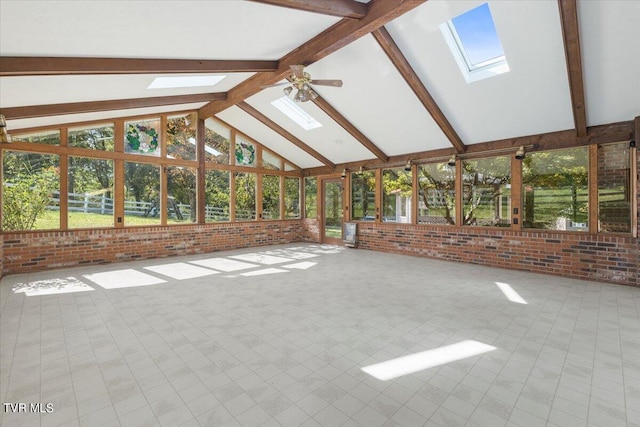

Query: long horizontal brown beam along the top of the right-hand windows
<box><xmin>303</xmin><ymin>121</ymin><xmax>634</xmax><ymax>176</ymax></box>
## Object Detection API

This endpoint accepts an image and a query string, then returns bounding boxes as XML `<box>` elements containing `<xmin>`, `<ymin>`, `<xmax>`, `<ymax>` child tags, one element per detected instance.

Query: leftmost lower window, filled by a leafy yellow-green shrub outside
<box><xmin>2</xmin><ymin>150</ymin><xmax>60</xmax><ymax>231</ymax></box>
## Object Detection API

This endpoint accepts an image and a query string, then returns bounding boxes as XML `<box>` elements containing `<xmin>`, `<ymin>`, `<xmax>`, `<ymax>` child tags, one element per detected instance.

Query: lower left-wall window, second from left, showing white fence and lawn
<box><xmin>67</xmin><ymin>157</ymin><xmax>113</xmax><ymax>228</ymax></box>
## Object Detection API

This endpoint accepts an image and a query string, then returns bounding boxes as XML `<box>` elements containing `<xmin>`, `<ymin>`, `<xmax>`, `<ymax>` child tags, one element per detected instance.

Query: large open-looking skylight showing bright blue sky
<box><xmin>440</xmin><ymin>3</ymin><xmax>509</xmax><ymax>83</ymax></box>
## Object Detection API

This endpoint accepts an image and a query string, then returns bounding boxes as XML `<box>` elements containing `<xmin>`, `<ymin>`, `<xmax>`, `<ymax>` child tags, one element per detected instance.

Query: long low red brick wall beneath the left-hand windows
<box><xmin>0</xmin><ymin>220</ymin><xmax>302</xmax><ymax>275</ymax></box>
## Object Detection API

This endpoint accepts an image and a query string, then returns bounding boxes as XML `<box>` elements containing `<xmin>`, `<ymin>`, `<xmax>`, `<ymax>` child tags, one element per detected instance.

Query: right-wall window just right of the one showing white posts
<box><xmin>418</xmin><ymin>163</ymin><xmax>456</xmax><ymax>225</ymax></box>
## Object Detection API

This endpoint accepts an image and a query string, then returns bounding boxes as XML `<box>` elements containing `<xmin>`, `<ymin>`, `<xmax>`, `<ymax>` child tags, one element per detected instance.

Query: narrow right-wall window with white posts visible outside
<box><xmin>382</xmin><ymin>168</ymin><xmax>413</xmax><ymax>223</ymax></box>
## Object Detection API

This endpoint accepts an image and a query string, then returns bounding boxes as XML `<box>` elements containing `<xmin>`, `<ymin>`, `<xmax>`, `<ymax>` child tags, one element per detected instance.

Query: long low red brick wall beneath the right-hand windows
<box><xmin>358</xmin><ymin>223</ymin><xmax>640</xmax><ymax>286</ymax></box>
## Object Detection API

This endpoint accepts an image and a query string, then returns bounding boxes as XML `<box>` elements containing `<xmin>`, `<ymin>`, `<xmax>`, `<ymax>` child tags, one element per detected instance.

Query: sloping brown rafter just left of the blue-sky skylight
<box><xmin>371</xmin><ymin>27</ymin><xmax>466</xmax><ymax>153</ymax></box>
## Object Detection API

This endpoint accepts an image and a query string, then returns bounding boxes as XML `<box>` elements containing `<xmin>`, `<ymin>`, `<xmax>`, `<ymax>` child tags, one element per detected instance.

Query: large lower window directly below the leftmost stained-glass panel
<box><xmin>124</xmin><ymin>162</ymin><xmax>161</xmax><ymax>226</ymax></box>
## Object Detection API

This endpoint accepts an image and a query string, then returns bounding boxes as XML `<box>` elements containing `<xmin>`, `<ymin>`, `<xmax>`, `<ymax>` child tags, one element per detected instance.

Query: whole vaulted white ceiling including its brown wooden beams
<box><xmin>0</xmin><ymin>0</ymin><xmax>640</xmax><ymax>172</ymax></box>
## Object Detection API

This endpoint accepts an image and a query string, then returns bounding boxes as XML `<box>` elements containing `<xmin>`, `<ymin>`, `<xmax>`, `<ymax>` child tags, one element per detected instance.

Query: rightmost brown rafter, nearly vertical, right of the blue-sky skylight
<box><xmin>558</xmin><ymin>0</ymin><xmax>587</xmax><ymax>136</ymax></box>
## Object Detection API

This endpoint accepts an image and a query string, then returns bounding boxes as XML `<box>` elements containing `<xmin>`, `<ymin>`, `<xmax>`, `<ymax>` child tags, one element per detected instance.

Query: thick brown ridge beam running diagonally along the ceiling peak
<box><xmin>199</xmin><ymin>0</ymin><xmax>426</xmax><ymax>118</ymax></box>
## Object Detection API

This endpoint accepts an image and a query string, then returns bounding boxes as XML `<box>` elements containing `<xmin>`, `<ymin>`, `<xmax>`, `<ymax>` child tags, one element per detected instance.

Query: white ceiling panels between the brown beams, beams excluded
<box><xmin>0</xmin><ymin>0</ymin><xmax>640</xmax><ymax>168</ymax></box>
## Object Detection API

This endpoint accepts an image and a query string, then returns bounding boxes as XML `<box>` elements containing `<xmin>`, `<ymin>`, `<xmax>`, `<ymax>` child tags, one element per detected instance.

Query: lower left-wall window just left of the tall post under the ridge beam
<box><xmin>165</xmin><ymin>166</ymin><xmax>198</xmax><ymax>224</ymax></box>
